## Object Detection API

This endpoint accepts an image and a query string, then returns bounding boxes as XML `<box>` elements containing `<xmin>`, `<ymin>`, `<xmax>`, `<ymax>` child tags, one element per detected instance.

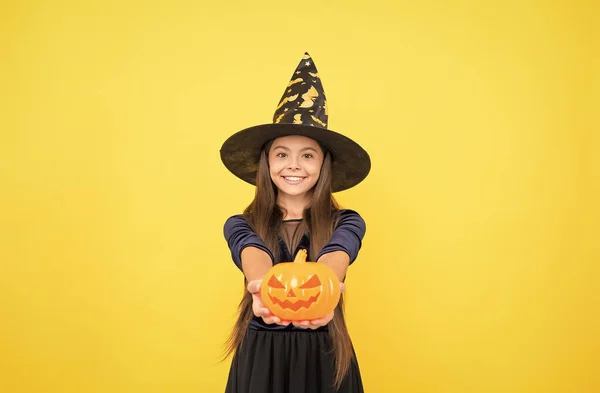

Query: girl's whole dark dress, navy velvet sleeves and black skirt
<box><xmin>225</xmin><ymin>210</ymin><xmax>365</xmax><ymax>393</ymax></box>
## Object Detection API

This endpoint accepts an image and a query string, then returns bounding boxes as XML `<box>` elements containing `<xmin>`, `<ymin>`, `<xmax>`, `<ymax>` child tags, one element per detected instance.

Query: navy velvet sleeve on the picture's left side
<box><xmin>223</xmin><ymin>215</ymin><xmax>274</xmax><ymax>270</ymax></box>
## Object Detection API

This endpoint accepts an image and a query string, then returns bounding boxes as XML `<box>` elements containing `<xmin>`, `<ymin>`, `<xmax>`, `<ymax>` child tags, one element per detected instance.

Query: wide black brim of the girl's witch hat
<box><xmin>220</xmin><ymin>123</ymin><xmax>371</xmax><ymax>192</ymax></box>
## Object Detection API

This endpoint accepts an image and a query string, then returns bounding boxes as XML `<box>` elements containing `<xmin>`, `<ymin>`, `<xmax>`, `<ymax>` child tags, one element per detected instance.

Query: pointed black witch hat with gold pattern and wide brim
<box><xmin>220</xmin><ymin>53</ymin><xmax>371</xmax><ymax>192</ymax></box>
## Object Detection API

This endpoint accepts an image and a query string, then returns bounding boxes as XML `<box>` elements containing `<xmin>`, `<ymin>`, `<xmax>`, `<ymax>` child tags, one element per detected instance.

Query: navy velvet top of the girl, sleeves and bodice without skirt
<box><xmin>223</xmin><ymin>209</ymin><xmax>366</xmax><ymax>330</ymax></box>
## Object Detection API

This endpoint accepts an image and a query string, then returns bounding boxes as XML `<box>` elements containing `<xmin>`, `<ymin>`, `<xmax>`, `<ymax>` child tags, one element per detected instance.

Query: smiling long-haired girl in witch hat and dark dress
<box><xmin>221</xmin><ymin>54</ymin><xmax>370</xmax><ymax>393</ymax></box>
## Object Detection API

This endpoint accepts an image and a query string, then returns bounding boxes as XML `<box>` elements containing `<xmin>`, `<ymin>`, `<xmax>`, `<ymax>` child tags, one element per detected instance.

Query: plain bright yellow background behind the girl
<box><xmin>0</xmin><ymin>0</ymin><xmax>600</xmax><ymax>393</ymax></box>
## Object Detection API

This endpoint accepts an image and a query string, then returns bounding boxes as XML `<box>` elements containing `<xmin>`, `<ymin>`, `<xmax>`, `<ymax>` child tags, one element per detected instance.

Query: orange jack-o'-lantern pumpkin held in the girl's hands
<box><xmin>261</xmin><ymin>250</ymin><xmax>341</xmax><ymax>321</ymax></box>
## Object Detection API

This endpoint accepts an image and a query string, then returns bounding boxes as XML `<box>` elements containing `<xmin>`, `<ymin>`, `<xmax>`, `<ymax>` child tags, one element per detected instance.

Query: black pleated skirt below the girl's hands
<box><xmin>225</xmin><ymin>329</ymin><xmax>364</xmax><ymax>393</ymax></box>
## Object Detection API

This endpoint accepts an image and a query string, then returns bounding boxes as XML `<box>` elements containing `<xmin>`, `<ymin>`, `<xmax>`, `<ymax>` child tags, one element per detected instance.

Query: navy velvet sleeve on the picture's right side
<box><xmin>317</xmin><ymin>209</ymin><xmax>367</xmax><ymax>264</ymax></box>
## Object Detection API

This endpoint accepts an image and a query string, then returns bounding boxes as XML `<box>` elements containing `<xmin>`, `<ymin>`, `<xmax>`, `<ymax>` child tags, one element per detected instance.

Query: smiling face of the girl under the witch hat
<box><xmin>269</xmin><ymin>135</ymin><xmax>324</xmax><ymax>196</ymax></box>
